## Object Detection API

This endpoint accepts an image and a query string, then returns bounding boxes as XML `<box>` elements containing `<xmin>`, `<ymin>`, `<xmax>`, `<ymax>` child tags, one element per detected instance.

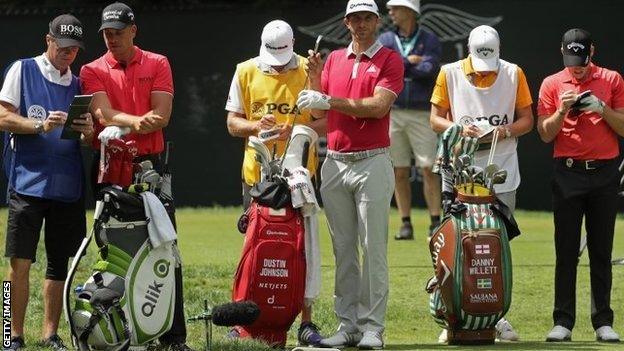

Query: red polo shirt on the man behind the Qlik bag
<box><xmin>80</xmin><ymin>46</ymin><xmax>173</xmax><ymax>155</ymax></box>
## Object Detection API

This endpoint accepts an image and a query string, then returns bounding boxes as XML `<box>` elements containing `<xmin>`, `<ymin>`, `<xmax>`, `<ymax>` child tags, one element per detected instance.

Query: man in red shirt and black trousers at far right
<box><xmin>537</xmin><ymin>29</ymin><xmax>624</xmax><ymax>342</ymax></box>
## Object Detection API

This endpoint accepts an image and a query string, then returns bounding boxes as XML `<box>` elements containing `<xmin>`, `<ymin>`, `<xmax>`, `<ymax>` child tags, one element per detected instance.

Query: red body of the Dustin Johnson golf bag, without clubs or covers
<box><xmin>232</xmin><ymin>201</ymin><xmax>306</xmax><ymax>347</ymax></box>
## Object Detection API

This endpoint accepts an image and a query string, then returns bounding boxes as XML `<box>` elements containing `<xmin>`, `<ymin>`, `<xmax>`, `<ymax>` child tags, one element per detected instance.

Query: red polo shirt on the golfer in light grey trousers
<box><xmin>321</xmin><ymin>42</ymin><xmax>403</xmax><ymax>152</ymax></box>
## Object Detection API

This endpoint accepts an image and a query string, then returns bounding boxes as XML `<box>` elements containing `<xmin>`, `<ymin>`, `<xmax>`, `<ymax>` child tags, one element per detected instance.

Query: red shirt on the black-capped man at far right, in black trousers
<box><xmin>537</xmin><ymin>63</ymin><xmax>624</xmax><ymax>160</ymax></box>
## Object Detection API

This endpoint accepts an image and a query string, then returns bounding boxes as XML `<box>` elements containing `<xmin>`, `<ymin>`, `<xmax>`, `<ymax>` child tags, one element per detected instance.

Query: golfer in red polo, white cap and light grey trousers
<box><xmin>297</xmin><ymin>0</ymin><xmax>403</xmax><ymax>349</ymax></box>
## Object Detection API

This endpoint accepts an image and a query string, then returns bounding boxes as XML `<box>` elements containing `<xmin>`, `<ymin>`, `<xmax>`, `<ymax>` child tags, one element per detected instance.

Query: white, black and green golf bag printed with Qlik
<box><xmin>64</xmin><ymin>187</ymin><xmax>179</xmax><ymax>350</ymax></box>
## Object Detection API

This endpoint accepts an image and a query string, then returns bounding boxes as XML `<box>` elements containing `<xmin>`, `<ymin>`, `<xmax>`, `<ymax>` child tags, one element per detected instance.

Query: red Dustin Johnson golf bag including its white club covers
<box><xmin>232</xmin><ymin>125</ymin><xmax>318</xmax><ymax>347</ymax></box>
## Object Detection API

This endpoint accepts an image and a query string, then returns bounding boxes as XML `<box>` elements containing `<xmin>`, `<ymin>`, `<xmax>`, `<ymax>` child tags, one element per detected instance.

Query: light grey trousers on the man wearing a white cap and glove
<box><xmin>321</xmin><ymin>153</ymin><xmax>394</xmax><ymax>332</ymax></box>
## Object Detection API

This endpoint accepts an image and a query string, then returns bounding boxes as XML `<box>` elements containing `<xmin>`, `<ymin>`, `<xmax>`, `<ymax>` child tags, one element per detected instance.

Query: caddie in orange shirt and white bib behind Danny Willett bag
<box><xmin>430</xmin><ymin>26</ymin><xmax>533</xmax><ymax>342</ymax></box>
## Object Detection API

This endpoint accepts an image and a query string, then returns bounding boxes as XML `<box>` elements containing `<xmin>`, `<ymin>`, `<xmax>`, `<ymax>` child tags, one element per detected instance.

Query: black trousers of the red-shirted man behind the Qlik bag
<box><xmin>91</xmin><ymin>152</ymin><xmax>186</xmax><ymax>345</ymax></box>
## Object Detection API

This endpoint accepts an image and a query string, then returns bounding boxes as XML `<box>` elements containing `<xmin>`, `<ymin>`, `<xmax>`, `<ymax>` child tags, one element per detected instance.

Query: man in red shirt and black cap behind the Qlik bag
<box><xmin>80</xmin><ymin>2</ymin><xmax>190</xmax><ymax>350</ymax></box>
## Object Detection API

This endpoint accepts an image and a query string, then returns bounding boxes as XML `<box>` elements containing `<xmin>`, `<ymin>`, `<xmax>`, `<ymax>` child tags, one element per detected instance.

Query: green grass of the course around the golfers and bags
<box><xmin>0</xmin><ymin>207</ymin><xmax>624</xmax><ymax>351</ymax></box>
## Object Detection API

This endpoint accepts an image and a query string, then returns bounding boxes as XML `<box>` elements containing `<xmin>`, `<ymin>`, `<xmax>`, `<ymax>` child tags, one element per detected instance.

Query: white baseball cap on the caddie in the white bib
<box><xmin>468</xmin><ymin>26</ymin><xmax>500</xmax><ymax>72</ymax></box>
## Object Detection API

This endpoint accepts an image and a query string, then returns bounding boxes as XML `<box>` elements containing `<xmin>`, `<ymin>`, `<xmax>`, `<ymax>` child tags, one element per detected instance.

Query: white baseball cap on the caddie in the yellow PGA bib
<box><xmin>260</xmin><ymin>20</ymin><xmax>295</xmax><ymax>66</ymax></box>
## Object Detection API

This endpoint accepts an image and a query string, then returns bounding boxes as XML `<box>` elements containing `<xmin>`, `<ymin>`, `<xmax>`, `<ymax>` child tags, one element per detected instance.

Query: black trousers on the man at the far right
<box><xmin>552</xmin><ymin>160</ymin><xmax>619</xmax><ymax>330</ymax></box>
